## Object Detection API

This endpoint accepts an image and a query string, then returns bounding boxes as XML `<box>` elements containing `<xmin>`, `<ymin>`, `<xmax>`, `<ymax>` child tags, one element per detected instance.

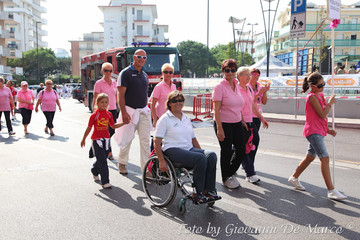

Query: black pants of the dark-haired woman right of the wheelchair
<box><xmin>214</xmin><ymin>122</ymin><xmax>246</xmax><ymax>181</ymax></box>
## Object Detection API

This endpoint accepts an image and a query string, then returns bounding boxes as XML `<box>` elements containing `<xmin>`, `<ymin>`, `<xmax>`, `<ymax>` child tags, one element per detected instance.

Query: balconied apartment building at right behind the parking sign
<box><xmin>271</xmin><ymin>2</ymin><xmax>360</xmax><ymax>74</ymax></box>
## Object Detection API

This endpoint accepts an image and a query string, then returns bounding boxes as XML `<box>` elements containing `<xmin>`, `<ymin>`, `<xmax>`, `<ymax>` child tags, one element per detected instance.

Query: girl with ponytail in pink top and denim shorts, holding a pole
<box><xmin>289</xmin><ymin>72</ymin><xmax>347</xmax><ymax>200</ymax></box>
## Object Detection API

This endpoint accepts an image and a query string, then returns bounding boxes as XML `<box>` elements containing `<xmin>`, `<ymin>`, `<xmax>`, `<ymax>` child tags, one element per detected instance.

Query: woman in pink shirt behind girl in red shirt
<box><xmin>93</xmin><ymin>62</ymin><xmax>119</xmax><ymax>161</ymax></box>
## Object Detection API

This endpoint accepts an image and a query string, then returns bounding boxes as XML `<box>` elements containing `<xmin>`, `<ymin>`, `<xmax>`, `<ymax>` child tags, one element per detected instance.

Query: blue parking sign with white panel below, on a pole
<box><xmin>290</xmin><ymin>0</ymin><xmax>306</xmax><ymax>38</ymax></box>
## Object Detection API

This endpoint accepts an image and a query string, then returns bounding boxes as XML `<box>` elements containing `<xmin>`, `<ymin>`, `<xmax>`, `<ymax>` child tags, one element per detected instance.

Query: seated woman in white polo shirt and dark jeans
<box><xmin>154</xmin><ymin>91</ymin><xmax>221</xmax><ymax>204</ymax></box>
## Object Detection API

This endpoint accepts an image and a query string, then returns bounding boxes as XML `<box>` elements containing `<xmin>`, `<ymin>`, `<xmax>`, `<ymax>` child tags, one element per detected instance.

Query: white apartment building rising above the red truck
<box><xmin>99</xmin><ymin>0</ymin><xmax>168</xmax><ymax>49</ymax></box>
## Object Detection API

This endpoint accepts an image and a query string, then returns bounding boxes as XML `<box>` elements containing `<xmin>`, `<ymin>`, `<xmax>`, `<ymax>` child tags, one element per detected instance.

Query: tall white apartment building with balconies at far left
<box><xmin>0</xmin><ymin>0</ymin><xmax>47</xmax><ymax>76</ymax></box>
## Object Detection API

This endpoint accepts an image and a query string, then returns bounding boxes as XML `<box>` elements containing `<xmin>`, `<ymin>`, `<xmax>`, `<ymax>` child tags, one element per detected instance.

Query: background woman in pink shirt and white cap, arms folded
<box><xmin>17</xmin><ymin>81</ymin><xmax>34</xmax><ymax>134</ymax></box>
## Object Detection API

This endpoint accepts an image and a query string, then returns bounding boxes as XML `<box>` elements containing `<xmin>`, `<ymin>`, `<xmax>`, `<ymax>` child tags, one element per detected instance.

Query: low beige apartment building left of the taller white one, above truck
<box><xmin>69</xmin><ymin>32</ymin><xmax>104</xmax><ymax>76</ymax></box>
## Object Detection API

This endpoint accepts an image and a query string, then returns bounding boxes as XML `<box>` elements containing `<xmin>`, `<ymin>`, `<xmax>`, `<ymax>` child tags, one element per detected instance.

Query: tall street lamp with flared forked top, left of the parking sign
<box><xmin>260</xmin><ymin>0</ymin><xmax>280</xmax><ymax>77</ymax></box>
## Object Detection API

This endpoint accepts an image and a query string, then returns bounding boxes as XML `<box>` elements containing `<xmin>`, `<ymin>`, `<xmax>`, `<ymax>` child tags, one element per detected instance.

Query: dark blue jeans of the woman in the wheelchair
<box><xmin>164</xmin><ymin>148</ymin><xmax>217</xmax><ymax>193</ymax></box>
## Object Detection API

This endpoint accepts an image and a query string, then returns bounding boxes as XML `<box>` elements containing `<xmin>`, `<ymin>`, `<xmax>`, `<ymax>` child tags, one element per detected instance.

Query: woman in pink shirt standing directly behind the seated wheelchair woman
<box><xmin>150</xmin><ymin>63</ymin><xmax>176</xmax><ymax>127</ymax></box>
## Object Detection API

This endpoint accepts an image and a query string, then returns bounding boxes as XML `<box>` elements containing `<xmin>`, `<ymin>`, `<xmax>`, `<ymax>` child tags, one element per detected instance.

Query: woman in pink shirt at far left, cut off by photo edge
<box><xmin>0</xmin><ymin>77</ymin><xmax>15</xmax><ymax>136</ymax></box>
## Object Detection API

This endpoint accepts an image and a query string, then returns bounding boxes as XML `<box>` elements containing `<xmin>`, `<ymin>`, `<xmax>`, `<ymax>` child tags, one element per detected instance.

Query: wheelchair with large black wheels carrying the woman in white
<box><xmin>142</xmin><ymin>153</ymin><xmax>215</xmax><ymax>214</ymax></box>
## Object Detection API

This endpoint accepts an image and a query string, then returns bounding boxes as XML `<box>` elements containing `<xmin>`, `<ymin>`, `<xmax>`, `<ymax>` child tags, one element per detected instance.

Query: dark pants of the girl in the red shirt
<box><xmin>91</xmin><ymin>139</ymin><xmax>110</xmax><ymax>185</ymax></box>
